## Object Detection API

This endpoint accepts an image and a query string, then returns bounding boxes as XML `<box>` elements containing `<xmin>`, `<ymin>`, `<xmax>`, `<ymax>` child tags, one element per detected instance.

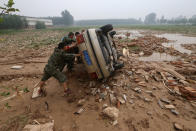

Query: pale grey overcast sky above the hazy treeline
<box><xmin>0</xmin><ymin>0</ymin><xmax>196</xmax><ymax>20</ymax></box>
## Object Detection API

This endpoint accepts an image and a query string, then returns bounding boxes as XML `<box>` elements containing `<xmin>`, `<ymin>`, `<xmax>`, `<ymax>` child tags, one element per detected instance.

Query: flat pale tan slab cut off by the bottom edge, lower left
<box><xmin>22</xmin><ymin>120</ymin><xmax>54</xmax><ymax>131</ymax></box>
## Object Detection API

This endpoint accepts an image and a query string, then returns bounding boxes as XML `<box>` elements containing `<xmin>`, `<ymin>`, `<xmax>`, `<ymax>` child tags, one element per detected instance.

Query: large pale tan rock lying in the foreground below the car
<box><xmin>103</xmin><ymin>107</ymin><xmax>119</xmax><ymax>120</ymax></box>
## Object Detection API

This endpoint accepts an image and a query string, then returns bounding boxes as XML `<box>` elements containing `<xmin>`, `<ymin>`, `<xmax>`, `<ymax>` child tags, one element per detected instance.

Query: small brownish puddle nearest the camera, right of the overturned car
<box><xmin>139</xmin><ymin>52</ymin><xmax>179</xmax><ymax>61</ymax></box>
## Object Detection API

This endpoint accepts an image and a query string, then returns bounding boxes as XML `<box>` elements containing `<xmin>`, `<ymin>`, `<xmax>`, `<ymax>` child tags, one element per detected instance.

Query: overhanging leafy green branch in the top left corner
<box><xmin>0</xmin><ymin>0</ymin><xmax>19</xmax><ymax>16</ymax></box>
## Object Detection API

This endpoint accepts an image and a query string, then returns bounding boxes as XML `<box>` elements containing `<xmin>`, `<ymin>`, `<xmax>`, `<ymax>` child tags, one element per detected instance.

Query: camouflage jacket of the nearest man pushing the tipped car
<box><xmin>45</xmin><ymin>47</ymin><xmax>75</xmax><ymax>72</ymax></box>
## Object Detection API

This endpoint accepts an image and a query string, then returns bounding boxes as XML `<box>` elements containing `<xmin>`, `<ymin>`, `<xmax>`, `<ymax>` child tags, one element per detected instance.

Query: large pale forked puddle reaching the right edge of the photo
<box><xmin>156</xmin><ymin>34</ymin><xmax>196</xmax><ymax>54</ymax></box>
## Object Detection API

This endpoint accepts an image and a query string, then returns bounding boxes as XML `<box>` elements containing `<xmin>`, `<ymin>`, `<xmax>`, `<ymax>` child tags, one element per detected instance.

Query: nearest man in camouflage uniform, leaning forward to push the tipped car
<box><xmin>39</xmin><ymin>42</ymin><xmax>81</xmax><ymax>95</ymax></box>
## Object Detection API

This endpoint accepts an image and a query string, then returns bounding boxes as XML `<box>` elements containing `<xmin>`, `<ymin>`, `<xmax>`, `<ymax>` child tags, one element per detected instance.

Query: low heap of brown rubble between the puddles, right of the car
<box><xmin>116</xmin><ymin>35</ymin><xmax>186</xmax><ymax>57</ymax></box>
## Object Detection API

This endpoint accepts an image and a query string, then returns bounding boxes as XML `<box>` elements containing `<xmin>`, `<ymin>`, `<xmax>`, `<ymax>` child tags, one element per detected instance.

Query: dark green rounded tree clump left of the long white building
<box><xmin>0</xmin><ymin>15</ymin><xmax>28</xmax><ymax>29</ymax></box>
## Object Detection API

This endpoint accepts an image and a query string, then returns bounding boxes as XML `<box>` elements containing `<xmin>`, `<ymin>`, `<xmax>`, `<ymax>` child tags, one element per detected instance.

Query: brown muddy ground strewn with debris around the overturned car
<box><xmin>0</xmin><ymin>31</ymin><xmax>196</xmax><ymax>131</ymax></box>
